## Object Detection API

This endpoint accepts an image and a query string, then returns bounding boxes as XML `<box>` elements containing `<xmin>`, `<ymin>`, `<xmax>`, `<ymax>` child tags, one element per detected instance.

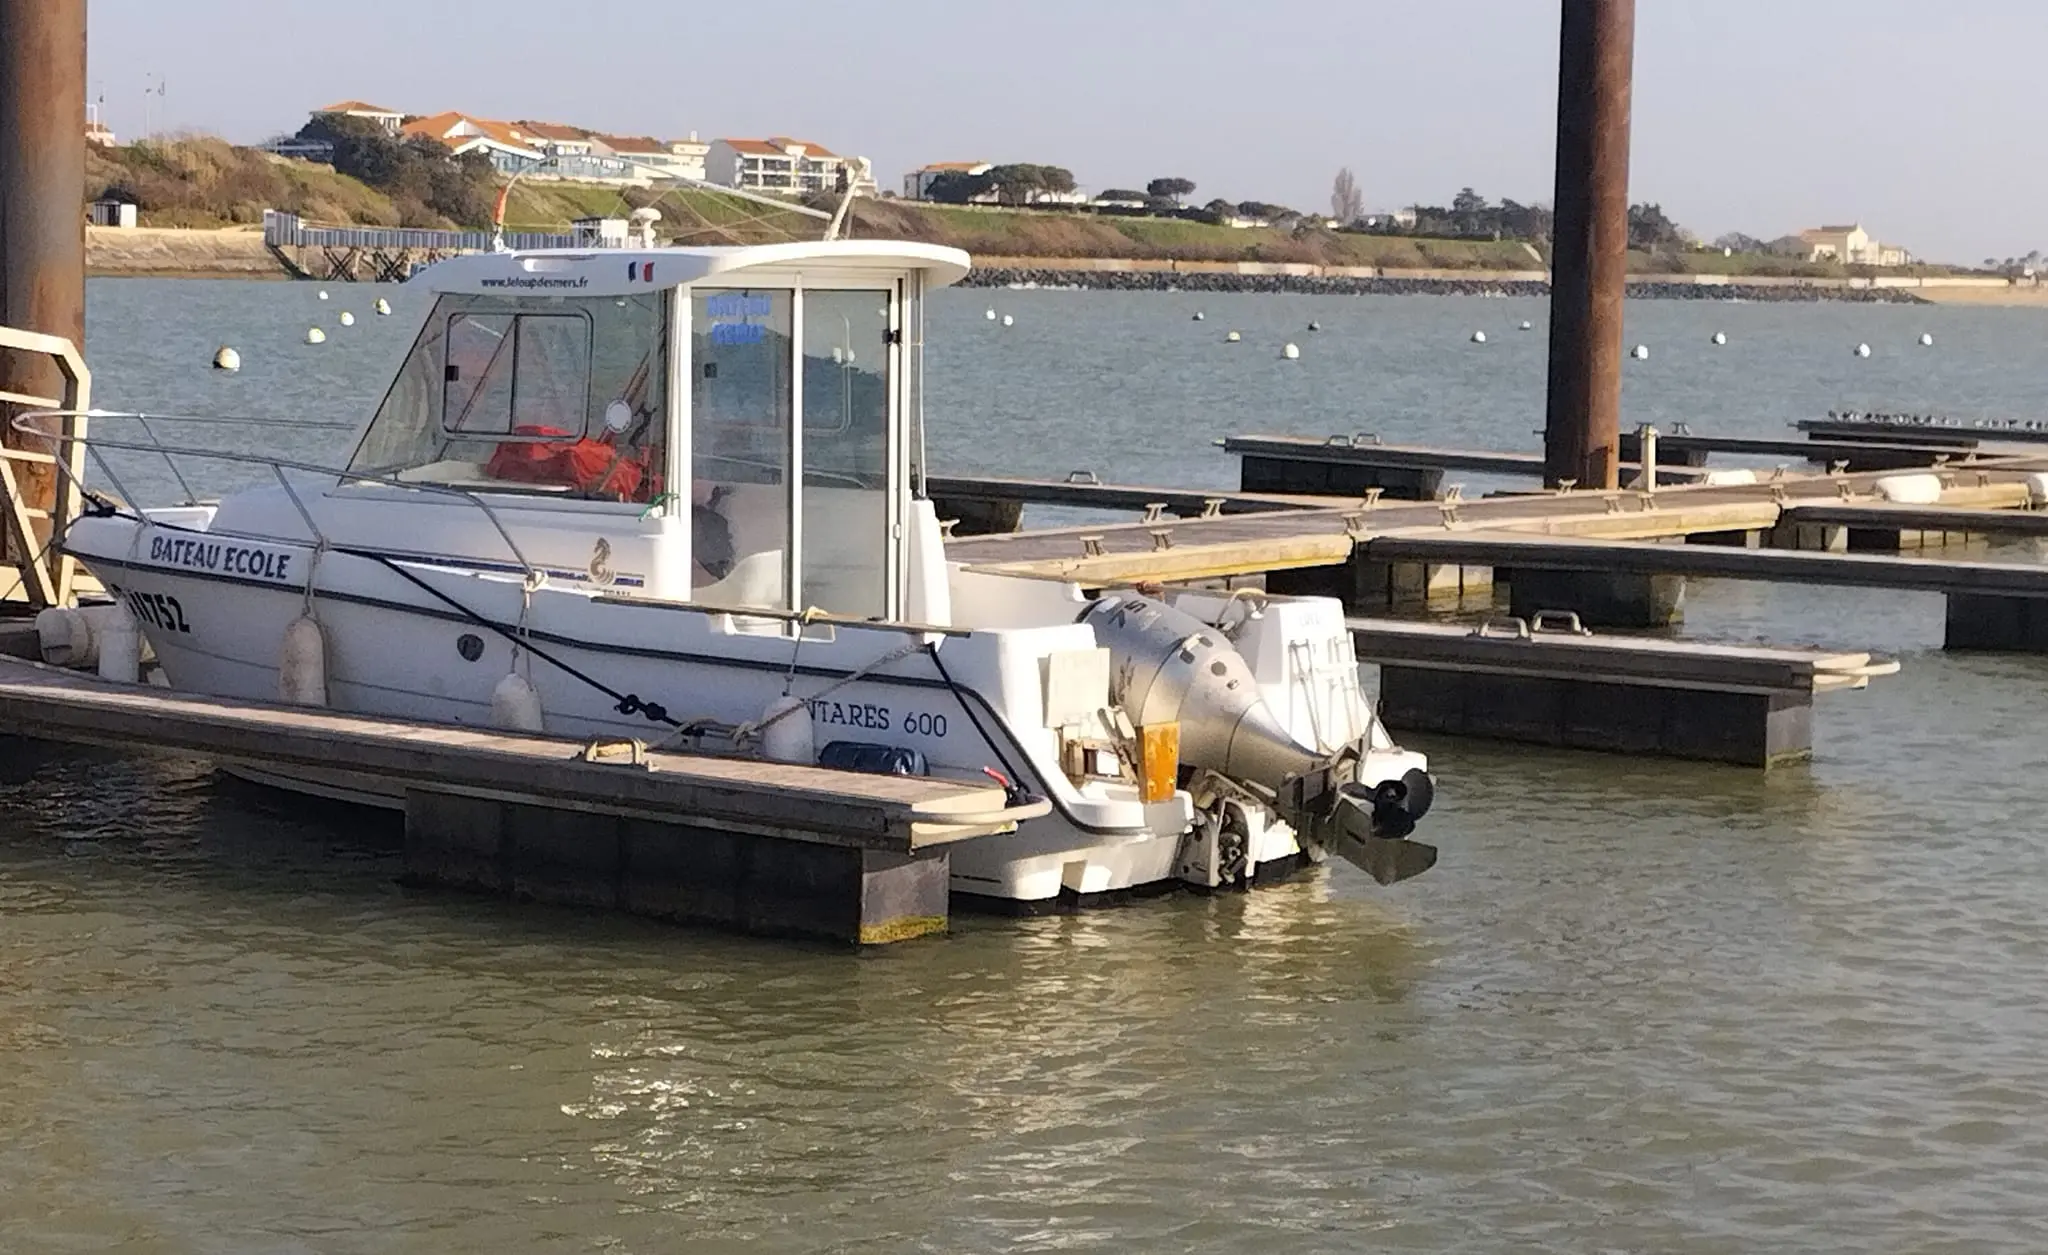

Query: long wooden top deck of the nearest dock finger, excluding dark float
<box><xmin>0</xmin><ymin>659</ymin><xmax>1014</xmax><ymax>854</ymax></box>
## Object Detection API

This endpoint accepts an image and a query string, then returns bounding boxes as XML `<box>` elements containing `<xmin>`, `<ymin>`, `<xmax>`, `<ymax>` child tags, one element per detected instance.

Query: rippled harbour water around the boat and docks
<box><xmin>0</xmin><ymin>280</ymin><xmax>2048</xmax><ymax>1255</ymax></box>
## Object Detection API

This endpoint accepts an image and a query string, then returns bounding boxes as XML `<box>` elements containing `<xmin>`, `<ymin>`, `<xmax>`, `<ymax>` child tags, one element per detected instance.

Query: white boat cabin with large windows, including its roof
<box><xmin>338</xmin><ymin>240</ymin><xmax>969</xmax><ymax>620</ymax></box>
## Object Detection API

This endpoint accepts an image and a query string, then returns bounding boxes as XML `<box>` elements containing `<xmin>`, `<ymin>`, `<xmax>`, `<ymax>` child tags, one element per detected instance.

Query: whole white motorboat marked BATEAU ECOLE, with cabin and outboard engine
<box><xmin>66</xmin><ymin>242</ymin><xmax>1436</xmax><ymax>903</ymax></box>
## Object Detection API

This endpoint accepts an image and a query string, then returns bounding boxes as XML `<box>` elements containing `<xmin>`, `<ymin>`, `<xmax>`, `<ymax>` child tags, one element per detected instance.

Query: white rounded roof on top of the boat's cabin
<box><xmin>416</xmin><ymin>240</ymin><xmax>973</xmax><ymax>297</ymax></box>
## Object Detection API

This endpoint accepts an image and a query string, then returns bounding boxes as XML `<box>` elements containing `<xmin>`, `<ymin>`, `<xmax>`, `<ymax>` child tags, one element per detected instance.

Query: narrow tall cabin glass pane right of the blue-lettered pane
<box><xmin>801</xmin><ymin>289</ymin><xmax>891</xmax><ymax>618</ymax></box>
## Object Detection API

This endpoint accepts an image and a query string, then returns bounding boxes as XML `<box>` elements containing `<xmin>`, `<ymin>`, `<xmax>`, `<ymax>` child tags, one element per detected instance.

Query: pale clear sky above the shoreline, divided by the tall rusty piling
<box><xmin>90</xmin><ymin>0</ymin><xmax>2048</xmax><ymax>262</ymax></box>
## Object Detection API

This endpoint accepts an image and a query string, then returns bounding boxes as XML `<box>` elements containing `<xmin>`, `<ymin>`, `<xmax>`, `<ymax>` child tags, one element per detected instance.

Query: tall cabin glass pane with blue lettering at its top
<box><xmin>690</xmin><ymin>289</ymin><xmax>795</xmax><ymax>610</ymax></box>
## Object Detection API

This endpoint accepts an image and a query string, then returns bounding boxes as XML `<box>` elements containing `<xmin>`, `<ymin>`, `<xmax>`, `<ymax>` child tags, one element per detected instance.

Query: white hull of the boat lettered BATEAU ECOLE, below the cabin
<box><xmin>72</xmin><ymin>518</ymin><xmax>1343</xmax><ymax>903</ymax></box>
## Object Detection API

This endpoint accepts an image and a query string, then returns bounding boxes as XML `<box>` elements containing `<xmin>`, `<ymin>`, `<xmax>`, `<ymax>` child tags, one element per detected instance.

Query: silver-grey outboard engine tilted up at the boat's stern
<box><xmin>1081</xmin><ymin>592</ymin><xmax>1436</xmax><ymax>884</ymax></box>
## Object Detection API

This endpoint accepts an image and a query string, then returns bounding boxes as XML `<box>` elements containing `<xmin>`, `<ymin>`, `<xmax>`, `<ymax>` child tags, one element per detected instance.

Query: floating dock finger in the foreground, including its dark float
<box><xmin>0</xmin><ymin>659</ymin><xmax>1042</xmax><ymax>944</ymax></box>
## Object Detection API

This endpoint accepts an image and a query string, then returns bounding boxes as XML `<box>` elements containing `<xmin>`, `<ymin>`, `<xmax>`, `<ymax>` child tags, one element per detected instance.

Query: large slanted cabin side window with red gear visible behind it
<box><xmin>348</xmin><ymin>293</ymin><xmax>668</xmax><ymax>504</ymax></box>
